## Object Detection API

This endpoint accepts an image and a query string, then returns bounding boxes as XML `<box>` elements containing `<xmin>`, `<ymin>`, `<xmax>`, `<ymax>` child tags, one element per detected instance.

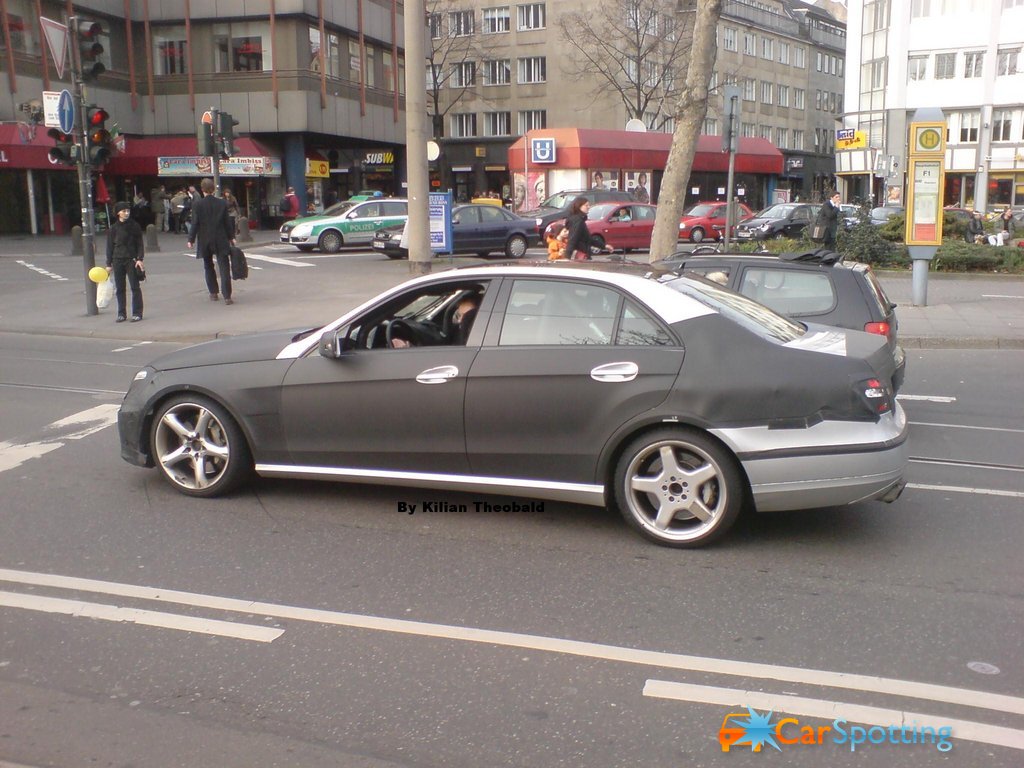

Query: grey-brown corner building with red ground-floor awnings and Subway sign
<box><xmin>0</xmin><ymin>0</ymin><xmax>406</xmax><ymax>231</ymax></box>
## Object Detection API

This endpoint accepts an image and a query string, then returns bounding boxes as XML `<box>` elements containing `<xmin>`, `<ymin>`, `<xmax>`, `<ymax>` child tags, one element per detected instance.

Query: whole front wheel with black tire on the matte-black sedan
<box><xmin>150</xmin><ymin>394</ymin><xmax>252</xmax><ymax>497</ymax></box>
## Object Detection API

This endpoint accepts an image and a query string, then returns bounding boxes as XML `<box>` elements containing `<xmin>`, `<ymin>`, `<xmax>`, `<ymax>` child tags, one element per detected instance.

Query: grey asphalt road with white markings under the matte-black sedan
<box><xmin>0</xmin><ymin>331</ymin><xmax>1024</xmax><ymax>768</ymax></box>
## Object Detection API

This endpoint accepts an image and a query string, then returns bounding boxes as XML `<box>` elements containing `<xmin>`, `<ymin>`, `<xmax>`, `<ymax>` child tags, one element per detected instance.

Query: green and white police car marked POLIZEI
<box><xmin>281</xmin><ymin>198</ymin><xmax>409</xmax><ymax>253</ymax></box>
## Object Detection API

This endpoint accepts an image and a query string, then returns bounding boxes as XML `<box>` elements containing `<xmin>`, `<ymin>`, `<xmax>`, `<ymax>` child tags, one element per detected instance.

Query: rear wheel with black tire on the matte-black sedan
<box><xmin>614</xmin><ymin>428</ymin><xmax>744</xmax><ymax>548</ymax></box>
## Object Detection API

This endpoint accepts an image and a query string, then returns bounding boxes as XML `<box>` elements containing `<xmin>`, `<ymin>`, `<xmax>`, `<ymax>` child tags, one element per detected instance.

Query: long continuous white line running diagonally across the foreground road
<box><xmin>0</xmin><ymin>568</ymin><xmax>1024</xmax><ymax>715</ymax></box>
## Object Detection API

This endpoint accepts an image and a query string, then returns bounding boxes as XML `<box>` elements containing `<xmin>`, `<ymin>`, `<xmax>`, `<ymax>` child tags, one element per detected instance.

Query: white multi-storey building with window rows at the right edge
<box><xmin>838</xmin><ymin>0</ymin><xmax>1024</xmax><ymax>210</ymax></box>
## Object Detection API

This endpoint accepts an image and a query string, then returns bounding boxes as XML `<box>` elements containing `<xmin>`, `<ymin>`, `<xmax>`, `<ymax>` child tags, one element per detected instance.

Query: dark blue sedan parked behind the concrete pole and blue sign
<box><xmin>373</xmin><ymin>203</ymin><xmax>541</xmax><ymax>259</ymax></box>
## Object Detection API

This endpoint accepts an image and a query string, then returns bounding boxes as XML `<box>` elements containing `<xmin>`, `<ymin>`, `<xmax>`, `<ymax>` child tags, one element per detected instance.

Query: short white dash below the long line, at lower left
<box><xmin>0</xmin><ymin>592</ymin><xmax>285</xmax><ymax>643</ymax></box>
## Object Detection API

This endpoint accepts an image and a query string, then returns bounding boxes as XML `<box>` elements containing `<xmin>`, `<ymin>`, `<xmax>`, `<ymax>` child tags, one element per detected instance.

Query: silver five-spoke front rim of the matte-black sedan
<box><xmin>153</xmin><ymin>400</ymin><xmax>232</xmax><ymax>494</ymax></box>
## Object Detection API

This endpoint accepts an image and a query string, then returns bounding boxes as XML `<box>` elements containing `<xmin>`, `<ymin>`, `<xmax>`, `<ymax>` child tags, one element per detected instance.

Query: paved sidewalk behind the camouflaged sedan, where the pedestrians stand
<box><xmin>0</xmin><ymin>230</ymin><xmax>1024</xmax><ymax>349</ymax></box>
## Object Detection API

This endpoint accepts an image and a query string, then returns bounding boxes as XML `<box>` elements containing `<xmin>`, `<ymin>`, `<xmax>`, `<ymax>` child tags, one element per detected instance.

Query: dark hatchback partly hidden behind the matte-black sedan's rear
<box><xmin>654</xmin><ymin>251</ymin><xmax>906</xmax><ymax>392</ymax></box>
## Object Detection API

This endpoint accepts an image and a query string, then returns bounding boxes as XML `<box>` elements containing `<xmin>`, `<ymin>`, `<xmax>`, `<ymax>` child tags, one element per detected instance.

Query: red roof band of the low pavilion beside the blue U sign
<box><xmin>509</xmin><ymin>128</ymin><xmax>783</xmax><ymax>174</ymax></box>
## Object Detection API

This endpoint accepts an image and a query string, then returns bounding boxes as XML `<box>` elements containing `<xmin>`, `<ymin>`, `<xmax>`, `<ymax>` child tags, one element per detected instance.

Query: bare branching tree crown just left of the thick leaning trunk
<box><xmin>558</xmin><ymin>0</ymin><xmax>690</xmax><ymax>128</ymax></box>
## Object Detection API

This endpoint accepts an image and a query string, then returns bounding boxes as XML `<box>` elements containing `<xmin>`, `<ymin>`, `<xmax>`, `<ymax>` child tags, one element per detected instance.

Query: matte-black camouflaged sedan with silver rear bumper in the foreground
<box><xmin>118</xmin><ymin>262</ymin><xmax>907</xmax><ymax>547</ymax></box>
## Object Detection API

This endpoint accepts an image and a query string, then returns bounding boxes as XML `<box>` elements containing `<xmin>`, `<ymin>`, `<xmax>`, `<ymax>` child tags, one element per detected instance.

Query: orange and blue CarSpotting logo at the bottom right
<box><xmin>718</xmin><ymin>707</ymin><xmax>953</xmax><ymax>752</ymax></box>
